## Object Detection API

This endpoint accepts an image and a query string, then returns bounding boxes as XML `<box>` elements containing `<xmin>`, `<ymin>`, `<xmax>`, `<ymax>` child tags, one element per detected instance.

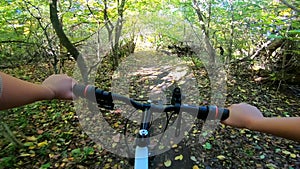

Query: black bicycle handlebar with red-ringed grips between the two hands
<box><xmin>73</xmin><ymin>84</ymin><xmax>229</xmax><ymax>121</ymax></box>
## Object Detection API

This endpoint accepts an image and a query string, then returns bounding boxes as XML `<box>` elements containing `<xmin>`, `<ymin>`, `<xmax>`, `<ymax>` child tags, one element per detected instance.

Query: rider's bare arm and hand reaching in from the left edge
<box><xmin>0</xmin><ymin>72</ymin><xmax>74</xmax><ymax>110</ymax></box>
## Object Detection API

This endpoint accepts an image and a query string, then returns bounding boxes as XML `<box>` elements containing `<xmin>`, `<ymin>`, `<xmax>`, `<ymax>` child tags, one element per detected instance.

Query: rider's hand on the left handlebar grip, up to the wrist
<box><xmin>42</xmin><ymin>75</ymin><xmax>76</xmax><ymax>100</ymax></box>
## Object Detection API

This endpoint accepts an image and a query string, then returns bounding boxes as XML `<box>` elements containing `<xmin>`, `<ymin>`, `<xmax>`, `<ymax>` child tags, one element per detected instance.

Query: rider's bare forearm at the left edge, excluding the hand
<box><xmin>0</xmin><ymin>72</ymin><xmax>54</xmax><ymax>110</ymax></box>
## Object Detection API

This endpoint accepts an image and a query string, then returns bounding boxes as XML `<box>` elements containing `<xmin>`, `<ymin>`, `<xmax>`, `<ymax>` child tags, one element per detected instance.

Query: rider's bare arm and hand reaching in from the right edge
<box><xmin>223</xmin><ymin>103</ymin><xmax>300</xmax><ymax>142</ymax></box>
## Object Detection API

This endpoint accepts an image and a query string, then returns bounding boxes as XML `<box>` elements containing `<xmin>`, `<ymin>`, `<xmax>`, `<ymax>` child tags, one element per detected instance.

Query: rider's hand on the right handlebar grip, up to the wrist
<box><xmin>223</xmin><ymin>103</ymin><xmax>264</xmax><ymax>129</ymax></box>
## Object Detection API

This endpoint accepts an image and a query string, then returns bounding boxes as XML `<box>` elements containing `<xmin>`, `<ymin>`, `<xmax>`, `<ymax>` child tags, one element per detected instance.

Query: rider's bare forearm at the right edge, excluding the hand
<box><xmin>249</xmin><ymin>117</ymin><xmax>300</xmax><ymax>142</ymax></box>
